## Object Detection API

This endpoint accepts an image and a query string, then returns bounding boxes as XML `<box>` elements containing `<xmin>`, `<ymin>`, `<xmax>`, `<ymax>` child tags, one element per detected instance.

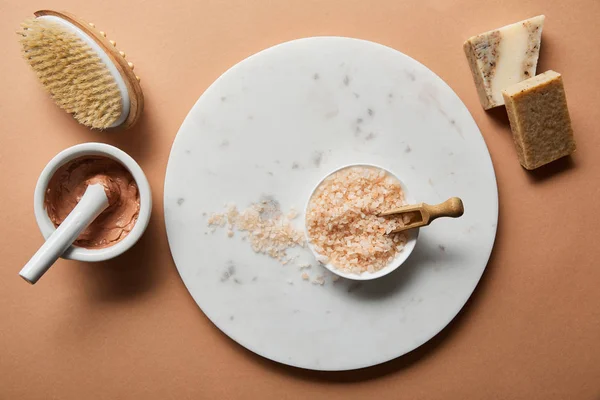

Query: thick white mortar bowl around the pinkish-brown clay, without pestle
<box><xmin>33</xmin><ymin>143</ymin><xmax>152</xmax><ymax>261</ymax></box>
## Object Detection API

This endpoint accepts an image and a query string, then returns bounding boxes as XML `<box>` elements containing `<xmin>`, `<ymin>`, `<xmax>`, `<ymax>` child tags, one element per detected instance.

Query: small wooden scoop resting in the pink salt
<box><xmin>379</xmin><ymin>197</ymin><xmax>465</xmax><ymax>233</ymax></box>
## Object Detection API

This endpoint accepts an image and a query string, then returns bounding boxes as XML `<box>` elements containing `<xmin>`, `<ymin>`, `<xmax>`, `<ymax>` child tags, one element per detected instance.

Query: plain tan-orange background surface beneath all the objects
<box><xmin>0</xmin><ymin>0</ymin><xmax>600</xmax><ymax>400</ymax></box>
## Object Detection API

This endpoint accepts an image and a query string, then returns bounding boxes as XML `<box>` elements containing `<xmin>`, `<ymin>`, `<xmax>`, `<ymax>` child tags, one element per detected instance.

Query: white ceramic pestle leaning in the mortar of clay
<box><xmin>19</xmin><ymin>183</ymin><xmax>109</xmax><ymax>285</ymax></box>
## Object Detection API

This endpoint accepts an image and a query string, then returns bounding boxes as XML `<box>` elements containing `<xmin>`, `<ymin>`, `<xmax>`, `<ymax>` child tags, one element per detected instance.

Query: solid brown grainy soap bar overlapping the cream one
<box><xmin>502</xmin><ymin>71</ymin><xmax>575</xmax><ymax>170</ymax></box>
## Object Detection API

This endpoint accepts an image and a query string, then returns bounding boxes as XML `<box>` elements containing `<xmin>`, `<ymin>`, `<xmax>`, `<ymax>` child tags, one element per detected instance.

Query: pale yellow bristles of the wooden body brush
<box><xmin>18</xmin><ymin>19</ymin><xmax>122</xmax><ymax>129</ymax></box>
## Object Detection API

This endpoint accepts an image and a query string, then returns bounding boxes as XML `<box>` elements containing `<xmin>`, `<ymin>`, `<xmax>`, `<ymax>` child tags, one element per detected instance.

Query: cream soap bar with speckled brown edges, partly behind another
<box><xmin>463</xmin><ymin>15</ymin><xmax>546</xmax><ymax>110</ymax></box>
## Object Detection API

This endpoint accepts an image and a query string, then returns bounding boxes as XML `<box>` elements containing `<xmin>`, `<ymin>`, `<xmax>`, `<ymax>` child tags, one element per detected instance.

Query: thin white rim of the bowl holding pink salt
<box><xmin>304</xmin><ymin>164</ymin><xmax>419</xmax><ymax>281</ymax></box>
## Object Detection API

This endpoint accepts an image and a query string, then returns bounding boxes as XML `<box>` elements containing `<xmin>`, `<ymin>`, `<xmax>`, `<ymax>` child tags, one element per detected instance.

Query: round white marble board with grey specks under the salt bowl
<box><xmin>165</xmin><ymin>38</ymin><xmax>498</xmax><ymax>370</ymax></box>
